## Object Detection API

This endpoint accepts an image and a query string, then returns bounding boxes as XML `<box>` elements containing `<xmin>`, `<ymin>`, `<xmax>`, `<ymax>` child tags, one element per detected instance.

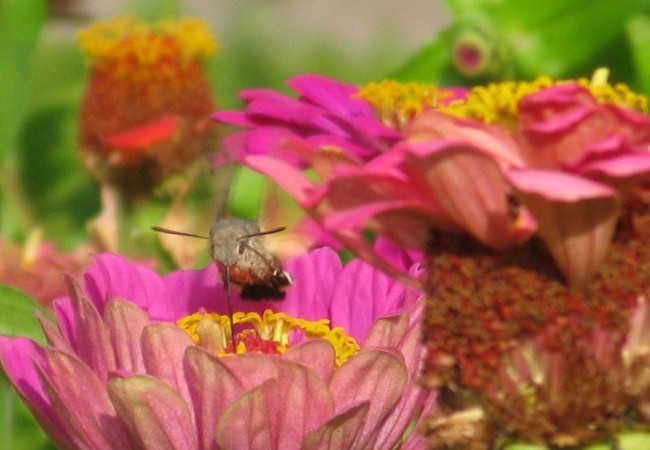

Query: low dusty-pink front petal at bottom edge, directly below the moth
<box><xmin>216</xmin><ymin>380</ymin><xmax>280</xmax><ymax>450</ymax></box>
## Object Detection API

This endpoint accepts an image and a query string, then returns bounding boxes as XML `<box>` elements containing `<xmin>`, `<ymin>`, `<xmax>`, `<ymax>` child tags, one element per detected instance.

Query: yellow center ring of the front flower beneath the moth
<box><xmin>177</xmin><ymin>309</ymin><xmax>359</xmax><ymax>366</ymax></box>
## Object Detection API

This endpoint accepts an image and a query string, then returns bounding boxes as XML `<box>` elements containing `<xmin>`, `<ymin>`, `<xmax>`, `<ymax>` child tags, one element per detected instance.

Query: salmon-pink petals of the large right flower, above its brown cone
<box><xmin>220</xmin><ymin>78</ymin><xmax>650</xmax><ymax>286</ymax></box>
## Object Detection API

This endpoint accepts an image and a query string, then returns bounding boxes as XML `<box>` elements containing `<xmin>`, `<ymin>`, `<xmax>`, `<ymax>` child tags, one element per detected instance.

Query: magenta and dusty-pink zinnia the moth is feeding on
<box><xmin>0</xmin><ymin>248</ymin><xmax>435</xmax><ymax>449</ymax></box>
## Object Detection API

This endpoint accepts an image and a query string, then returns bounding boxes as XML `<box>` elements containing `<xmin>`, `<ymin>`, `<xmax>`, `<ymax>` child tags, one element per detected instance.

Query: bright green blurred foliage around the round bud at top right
<box><xmin>395</xmin><ymin>0</ymin><xmax>650</xmax><ymax>89</ymax></box>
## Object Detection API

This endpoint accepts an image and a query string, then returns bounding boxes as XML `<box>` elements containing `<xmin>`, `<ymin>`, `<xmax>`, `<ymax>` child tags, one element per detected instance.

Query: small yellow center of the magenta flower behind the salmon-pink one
<box><xmin>356</xmin><ymin>80</ymin><xmax>449</xmax><ymax>130</ymax></box>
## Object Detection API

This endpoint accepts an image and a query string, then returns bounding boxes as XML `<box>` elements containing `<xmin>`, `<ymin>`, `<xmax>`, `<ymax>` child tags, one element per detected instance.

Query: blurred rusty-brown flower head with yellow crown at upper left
<box><xmin>79</xmin><ymin>17</ymin><xmax>217</xmax><ymax>194</ymax></box>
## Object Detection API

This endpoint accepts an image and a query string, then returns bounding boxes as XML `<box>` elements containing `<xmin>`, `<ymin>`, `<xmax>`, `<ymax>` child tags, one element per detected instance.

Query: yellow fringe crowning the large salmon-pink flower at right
<box><xmin>440</xmin><ymin>68</ymin><xmax>647</xmax><ymax>129</ymax></box>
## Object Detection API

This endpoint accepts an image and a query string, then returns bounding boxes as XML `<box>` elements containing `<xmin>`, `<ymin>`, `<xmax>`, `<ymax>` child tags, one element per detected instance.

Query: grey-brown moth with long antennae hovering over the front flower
<box><xmin>153</xmin><ymin>217</ymin><xmax>293</xmax><ymax>300</ymax></box>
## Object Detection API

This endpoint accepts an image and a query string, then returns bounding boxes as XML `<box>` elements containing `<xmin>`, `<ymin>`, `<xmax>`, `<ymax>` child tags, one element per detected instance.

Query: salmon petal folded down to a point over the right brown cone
<box><xmin>508</xmin><ymin>169</ymin><xmax>620</xmax><ymax>287</ymax></box>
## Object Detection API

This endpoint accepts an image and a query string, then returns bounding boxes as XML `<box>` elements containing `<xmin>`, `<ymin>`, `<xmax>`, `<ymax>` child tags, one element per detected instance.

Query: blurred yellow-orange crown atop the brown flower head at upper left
<box><xmin>77</xmin><ymin>16</ymin><xmax>217</xmax><ymax>82</ymax></box>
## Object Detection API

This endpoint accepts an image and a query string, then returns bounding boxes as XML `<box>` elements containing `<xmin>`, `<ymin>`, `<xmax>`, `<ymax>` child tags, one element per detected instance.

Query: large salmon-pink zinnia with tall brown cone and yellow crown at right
<box><xmin>211</xmin><ymin>71</ymin><xmax>650</xmax><ymax>450</ymax></box>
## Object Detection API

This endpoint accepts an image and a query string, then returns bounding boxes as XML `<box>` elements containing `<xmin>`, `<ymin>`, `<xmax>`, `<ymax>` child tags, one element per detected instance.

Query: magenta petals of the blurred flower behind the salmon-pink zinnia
<box><xmin>212</xmin><ymin>74</ymin><xmax>400</xmax><ymax>165</ymax></box>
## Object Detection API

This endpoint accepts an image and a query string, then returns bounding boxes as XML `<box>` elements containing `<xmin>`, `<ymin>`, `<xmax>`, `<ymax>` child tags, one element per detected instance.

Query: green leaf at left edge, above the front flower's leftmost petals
<box><xmin>0</xmin><ymin>284</ymin><xmax>49</xmax><ymax>345</ymax></box>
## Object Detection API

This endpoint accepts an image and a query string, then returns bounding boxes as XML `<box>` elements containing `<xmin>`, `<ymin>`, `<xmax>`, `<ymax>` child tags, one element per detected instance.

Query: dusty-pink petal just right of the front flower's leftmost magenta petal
<box><xmin>41</xmin><ymin>350</ymin><xmax>129</xmax><ymax>449</ymax></box>
